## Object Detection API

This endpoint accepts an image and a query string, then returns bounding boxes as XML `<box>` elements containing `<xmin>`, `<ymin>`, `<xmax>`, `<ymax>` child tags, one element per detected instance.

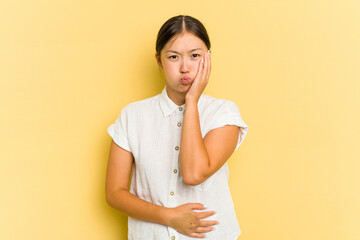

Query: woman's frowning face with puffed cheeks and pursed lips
<box><xmin>156</xmin><ymin>32</ymin><xmax>208</xmax><ymax>101</ymax></box>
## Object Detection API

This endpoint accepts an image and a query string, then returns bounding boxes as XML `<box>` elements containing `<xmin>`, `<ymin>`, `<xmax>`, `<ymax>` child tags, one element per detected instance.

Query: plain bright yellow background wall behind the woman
<box><xmin>0</xmin><ymin>0</ymin><xmax>360</xmax><ymax>240</ymax></box>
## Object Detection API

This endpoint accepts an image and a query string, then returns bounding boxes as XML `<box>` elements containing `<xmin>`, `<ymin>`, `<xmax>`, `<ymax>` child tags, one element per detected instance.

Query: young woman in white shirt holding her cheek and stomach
<box><xmin>106</xmin><ymin>15</ymin><xmax>248</xmax><ymax>240</ymax></box>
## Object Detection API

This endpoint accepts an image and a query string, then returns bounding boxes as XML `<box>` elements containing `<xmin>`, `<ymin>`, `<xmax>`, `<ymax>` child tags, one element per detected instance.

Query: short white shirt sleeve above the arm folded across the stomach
<box><xmin>107</xmin><ymin>108</ymin><xmax>131</xmax><ymax>152</ymax></box>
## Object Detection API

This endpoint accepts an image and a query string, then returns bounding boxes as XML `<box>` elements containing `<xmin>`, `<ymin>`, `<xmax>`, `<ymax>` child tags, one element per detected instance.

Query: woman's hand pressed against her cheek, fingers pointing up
<box><xmin>185</xmin><ymin>51</ymin><xmax>211</xmax><ymax>103</ymax></box>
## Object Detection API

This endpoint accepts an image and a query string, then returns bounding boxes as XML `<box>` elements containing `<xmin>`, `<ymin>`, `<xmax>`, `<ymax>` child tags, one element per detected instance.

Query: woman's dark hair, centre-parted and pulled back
<box><xmin>156</xmin><ymin>15</ymin><xmax>210</xmax><ymax>55</ymax></box>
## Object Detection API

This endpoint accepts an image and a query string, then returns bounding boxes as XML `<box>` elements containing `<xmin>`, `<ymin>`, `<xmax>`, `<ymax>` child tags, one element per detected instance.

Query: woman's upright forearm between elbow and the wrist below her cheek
<box><xmin>180</xmin><ymin>98</ymin><xmax>210</xmax><ymax>185</ymax></box>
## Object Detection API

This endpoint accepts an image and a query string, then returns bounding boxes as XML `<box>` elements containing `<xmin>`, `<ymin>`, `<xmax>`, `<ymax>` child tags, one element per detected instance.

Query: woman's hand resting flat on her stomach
<box><xmin>165</xmin><ymin>203</ymin><xmax>218</xmax><ymax>238</ymax></box>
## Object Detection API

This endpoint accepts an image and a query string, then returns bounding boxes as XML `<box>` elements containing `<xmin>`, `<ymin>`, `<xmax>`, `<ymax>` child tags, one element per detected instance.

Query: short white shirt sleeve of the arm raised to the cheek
<box><xmin>205</xmin><ymin>100</ymin><xmax>248</xmax><ymax>150</ymax></box>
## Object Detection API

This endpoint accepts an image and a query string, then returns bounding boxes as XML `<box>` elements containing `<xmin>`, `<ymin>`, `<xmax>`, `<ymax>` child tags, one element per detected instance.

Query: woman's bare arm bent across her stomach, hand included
<box><xmin>106</xmin><ymin>141</ymin><xmax>217</xmax><ymax>238</ymax></box>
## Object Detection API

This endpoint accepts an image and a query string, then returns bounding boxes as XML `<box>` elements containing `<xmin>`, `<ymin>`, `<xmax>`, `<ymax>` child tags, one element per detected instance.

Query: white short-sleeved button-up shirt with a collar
<box><xmin>108</xmin><ymin>87</ymin><xmax>248</xmax><ymax>240</ymax></box>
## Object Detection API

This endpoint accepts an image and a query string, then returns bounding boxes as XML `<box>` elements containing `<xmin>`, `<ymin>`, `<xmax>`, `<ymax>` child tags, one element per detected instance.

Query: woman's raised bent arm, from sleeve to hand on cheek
<box><xmin>180</xmin><ymin>52</ymin><xmax>239</xmax><ymax>185</ymax></box>
